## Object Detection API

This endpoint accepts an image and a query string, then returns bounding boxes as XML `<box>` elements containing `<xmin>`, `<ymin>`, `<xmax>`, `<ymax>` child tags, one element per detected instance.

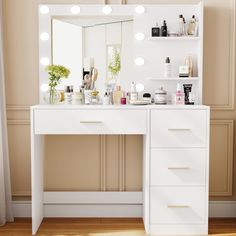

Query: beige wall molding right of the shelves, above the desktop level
<box><xmin>208</xmin><ymin>0</ymin><xmax>236</xmax><ymax>111</ymax></box>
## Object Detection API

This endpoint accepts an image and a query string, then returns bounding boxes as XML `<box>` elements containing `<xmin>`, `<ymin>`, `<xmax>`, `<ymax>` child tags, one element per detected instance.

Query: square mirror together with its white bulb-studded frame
<box><xmin>38</xmin><ymin>4</ymin><xmax>140</xmax><ymax>103</ymax></box>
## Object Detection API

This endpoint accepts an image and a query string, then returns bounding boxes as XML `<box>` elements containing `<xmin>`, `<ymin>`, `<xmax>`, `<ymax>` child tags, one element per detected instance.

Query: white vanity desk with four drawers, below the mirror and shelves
<box><xmin>31</xmin><ymin>105</ymin><xmax>209</xmax><ymax>235</ymax></box>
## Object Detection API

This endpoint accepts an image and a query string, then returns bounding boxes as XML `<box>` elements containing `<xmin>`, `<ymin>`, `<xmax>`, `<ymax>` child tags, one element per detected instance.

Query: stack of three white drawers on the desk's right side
<box><xmin>149</xmin><ymin>109</ymin><xmax>209</xmax><ymax>235</ymax></box>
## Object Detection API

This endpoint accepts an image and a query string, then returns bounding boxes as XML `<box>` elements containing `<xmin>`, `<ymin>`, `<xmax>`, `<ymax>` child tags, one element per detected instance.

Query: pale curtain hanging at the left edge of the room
<box><xmin>0</xmin><ymin>0</ymin><xmax>13</xmax><ymax>225</ymax></box>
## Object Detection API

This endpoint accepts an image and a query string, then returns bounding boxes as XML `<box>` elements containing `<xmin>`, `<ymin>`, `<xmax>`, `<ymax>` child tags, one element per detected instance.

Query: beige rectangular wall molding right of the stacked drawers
<box><xmin>209</xmin><ymin>120</ymin><xmax>234</xmax><ymax>197</ymax></box>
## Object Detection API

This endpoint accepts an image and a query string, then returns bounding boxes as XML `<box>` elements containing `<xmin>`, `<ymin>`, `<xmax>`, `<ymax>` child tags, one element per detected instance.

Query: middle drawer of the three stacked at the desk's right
<box><xmin>151</xmin><ymin>148</ymin><xmax>207</xmax><ymax>186</ymax></box>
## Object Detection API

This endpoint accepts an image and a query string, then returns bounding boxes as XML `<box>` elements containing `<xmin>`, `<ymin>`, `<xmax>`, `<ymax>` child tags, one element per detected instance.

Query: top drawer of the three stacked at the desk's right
<box><xmin>151</xmin><ymin>110</ymin><xmax>208</xmax><ymax>147</ymax></box>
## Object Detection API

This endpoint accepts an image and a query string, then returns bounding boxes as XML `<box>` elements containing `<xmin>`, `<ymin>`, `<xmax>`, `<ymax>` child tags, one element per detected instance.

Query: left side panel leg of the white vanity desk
<box><xmin>31</xmin><ymin>131</ymin><xmax>44</xmax><ymax>235</ymax></box>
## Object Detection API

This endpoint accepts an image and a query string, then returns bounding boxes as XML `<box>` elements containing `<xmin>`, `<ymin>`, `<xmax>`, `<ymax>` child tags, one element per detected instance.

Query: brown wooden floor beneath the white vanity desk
<box><xmin>0</xmin><ymin>218</ymin><xmax>236</xmax><ymax>236</ymax></box>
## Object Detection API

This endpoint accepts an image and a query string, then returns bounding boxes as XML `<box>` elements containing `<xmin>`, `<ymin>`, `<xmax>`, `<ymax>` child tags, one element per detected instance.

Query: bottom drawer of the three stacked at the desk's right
<box><xmin>150</xmin><ymin>187</ymin><xmax>207</xmax><ymax>224</ymax></box>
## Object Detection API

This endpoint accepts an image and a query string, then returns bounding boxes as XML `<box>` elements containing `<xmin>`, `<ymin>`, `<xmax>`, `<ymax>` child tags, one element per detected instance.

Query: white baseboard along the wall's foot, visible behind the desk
<box><xmin>13</xmin><ymin>201</ymin><xmax>236</xmax><ymax>218</ymax></box>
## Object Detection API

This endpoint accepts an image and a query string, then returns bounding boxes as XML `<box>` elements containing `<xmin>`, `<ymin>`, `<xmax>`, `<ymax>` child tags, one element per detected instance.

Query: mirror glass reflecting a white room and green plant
<box><xmin>52</xmin><ymin>15</ymin><xmax>134</xmax><ymax>92</ymax></box>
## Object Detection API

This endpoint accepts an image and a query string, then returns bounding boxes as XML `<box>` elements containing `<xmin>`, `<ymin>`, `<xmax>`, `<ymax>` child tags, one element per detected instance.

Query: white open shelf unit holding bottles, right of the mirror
<box><xmin>134</xmin><ymin>2</ymin><xmax>203</xmax><ymax>105</ymax></box>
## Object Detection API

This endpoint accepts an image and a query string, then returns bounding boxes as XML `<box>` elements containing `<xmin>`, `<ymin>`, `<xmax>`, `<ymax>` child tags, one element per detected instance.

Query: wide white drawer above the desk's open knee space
<box><xmin>34</xmin><ymin>109</ymin><xmax>147</xmax><ymax>134</ymax></box>
